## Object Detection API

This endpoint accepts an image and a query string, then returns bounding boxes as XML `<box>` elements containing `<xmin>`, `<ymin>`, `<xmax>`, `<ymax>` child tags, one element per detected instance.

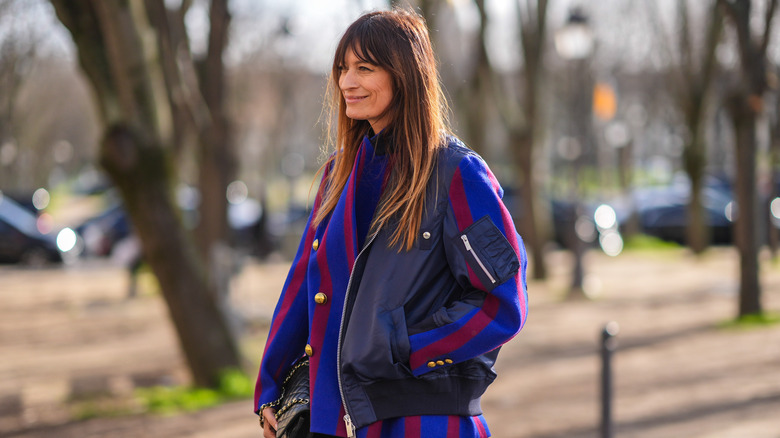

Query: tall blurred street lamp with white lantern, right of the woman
<box><xmin>555</xmin><ymin>7</ymin><xmax>595</xmax><ymax>298</ymax></box>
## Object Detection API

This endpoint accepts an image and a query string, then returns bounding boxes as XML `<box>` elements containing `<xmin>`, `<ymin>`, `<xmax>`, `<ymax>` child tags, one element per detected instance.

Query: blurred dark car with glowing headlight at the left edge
<box><xmin>0</xmin><ymin>192</ymin><xmax>77</xmax><ymax>266</ymax></box>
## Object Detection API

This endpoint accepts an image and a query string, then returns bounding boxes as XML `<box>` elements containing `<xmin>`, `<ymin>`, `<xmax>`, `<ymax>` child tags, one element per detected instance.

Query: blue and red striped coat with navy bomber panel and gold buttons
<box><xmin>255</xmin><ymin>137</ymin><xmax>528</xmax><ymax>438</ymax></box>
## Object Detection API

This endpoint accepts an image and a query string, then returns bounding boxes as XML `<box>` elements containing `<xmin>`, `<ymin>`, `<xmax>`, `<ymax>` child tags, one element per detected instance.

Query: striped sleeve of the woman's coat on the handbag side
<box><xmin>254</xmin><ymin>168</ymin><xmax>328</xmax><ymax>413</ymax></box>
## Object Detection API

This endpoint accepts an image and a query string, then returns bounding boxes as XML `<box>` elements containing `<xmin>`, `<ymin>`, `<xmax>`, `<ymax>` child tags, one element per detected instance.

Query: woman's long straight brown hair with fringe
<box><xmin>314</xmin><ymin>9</ymin><xmax>449</xmax><ymax>250</ymax></box>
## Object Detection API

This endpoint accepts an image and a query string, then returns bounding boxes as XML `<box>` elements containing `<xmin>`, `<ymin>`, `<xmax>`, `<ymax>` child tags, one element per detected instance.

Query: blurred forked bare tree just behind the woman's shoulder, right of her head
<box><xmin>390</xmin><ymin>0</ymin><xmax>548</xmax><ymax>279</ymax></box>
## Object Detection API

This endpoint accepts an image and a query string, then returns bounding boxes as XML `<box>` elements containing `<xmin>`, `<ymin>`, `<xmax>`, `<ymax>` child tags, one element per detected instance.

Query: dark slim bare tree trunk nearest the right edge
<box><xmin>718</xmin><ymin>0</ymin><xmax>777</xmax><ymax>317</ymax></box>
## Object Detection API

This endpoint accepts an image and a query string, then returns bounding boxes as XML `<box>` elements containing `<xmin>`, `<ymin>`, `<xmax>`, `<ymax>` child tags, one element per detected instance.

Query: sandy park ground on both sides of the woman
<box><xmin>0</xmin><ymin>248</ymin><xmax>780</xmax><ymax>438</ymax></box>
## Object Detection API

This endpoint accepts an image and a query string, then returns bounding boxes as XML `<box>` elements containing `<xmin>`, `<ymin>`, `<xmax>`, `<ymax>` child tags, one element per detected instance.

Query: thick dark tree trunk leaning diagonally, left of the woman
<box><xmin>51</xmin><ymin>0</ymin><xmax>240</xmax><ymax>386</ymax></box>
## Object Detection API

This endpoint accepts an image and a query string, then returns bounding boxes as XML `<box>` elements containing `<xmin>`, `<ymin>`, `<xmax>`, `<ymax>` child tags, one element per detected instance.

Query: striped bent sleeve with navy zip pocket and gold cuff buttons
<box><xmin>409</xmin><ymin>154</ymin><xmax>528</xmax><ymax>376</ymax></box>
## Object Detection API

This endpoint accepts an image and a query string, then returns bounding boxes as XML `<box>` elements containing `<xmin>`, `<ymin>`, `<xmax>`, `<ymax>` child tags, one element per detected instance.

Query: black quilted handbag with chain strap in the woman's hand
<box><xmin>276</xmin><ymin>358</ymin><xmax>314</xmax><ymax>438</ymax></box>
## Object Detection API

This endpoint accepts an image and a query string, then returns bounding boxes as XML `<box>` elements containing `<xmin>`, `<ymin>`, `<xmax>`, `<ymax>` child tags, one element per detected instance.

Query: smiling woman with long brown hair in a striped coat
<box><xmin>255</xmin><ymin>10</ymin><xmax>527</xmax><ymax>438</ymax></box>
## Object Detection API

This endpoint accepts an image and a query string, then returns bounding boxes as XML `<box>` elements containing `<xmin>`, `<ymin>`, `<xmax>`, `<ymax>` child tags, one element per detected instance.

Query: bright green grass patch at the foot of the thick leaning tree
<box><xmin>136</xmin><ymin>370</ymin><xmax>254</xmax><ymax>414</ymax></box>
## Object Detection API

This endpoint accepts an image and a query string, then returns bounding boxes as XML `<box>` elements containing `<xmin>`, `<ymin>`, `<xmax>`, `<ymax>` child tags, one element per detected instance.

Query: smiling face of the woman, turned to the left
<box><xmin>339</xmin><ymin>50</ymin><xmax>393</xmax><ymax>133</ymax></box>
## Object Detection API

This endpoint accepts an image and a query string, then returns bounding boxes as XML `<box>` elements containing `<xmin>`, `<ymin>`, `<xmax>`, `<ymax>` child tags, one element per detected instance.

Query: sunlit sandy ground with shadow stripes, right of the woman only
<box><xmin>485</xmin><ymin>249</ymin><xmax>780</xmax><ymax>438</ymax></box>
